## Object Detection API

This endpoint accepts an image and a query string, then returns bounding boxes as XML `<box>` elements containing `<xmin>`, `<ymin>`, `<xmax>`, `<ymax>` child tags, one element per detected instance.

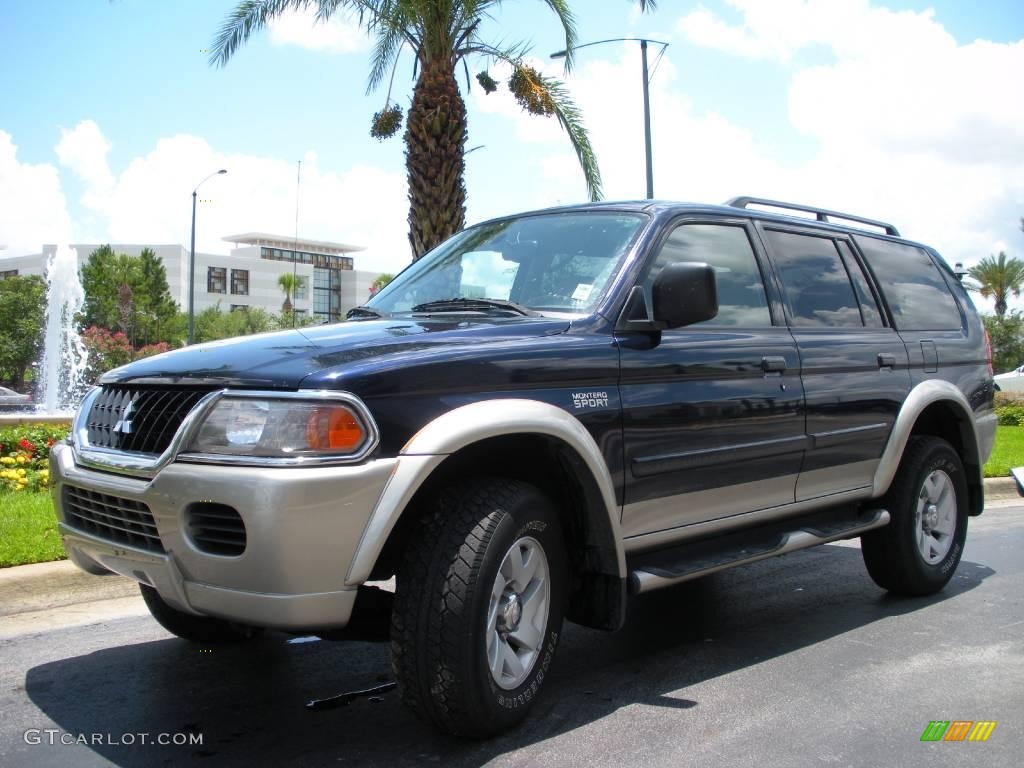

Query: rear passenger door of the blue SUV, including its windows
<box><xmin>759</xmin><ymin>224</ymin><xmax>910</xmax><ymax>501</ymax></box>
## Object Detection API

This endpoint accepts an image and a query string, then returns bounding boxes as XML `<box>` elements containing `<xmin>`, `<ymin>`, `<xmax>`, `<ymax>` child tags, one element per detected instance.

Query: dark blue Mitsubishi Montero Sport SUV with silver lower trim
<box><xmin>51</xmin><ymin>199</ymin><xmax>995</xmax><ymax>735</ymax></box>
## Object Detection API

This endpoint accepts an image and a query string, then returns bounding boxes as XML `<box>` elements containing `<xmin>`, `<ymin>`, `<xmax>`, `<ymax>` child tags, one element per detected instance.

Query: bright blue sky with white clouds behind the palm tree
<box><xmin>0</xmin><ymin>0</ymin><xmax>1024</xmax><ymax>278</ymax></box>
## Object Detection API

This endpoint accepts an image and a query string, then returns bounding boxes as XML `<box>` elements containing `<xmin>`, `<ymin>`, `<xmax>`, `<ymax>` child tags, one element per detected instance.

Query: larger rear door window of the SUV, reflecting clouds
<box><xmin>765</xmin><ymin>229</ymin><xmax>864</xmax><ymax>328</ymax></box>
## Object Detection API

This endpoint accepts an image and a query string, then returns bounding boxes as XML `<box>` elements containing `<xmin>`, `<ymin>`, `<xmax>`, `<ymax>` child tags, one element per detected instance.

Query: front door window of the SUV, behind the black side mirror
<box><xmin>644</xmin><ymin>224</ymin><xmax>771</xmax><ymax>328</ymax></box>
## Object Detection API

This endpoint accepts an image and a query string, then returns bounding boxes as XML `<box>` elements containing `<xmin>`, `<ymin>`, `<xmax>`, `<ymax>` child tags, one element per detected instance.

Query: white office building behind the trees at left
<box><xmin>0</xmin><ymin>232</ymin><xmax>378</xmax><ymax>323</ymax></box>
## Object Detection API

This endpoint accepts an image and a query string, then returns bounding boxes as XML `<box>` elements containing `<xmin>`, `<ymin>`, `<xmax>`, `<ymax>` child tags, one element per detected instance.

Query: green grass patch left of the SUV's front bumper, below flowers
<box><xmin>0</xmin><ymin>492</ymin><xmax>65</xmax><ymax>568</ymax></box>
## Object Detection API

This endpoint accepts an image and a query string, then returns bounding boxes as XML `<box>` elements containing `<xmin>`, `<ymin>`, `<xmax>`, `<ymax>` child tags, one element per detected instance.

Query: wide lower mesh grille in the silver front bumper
<box><xmin>63</xmin><ymin>485</ymin><xmax>164</xmax><ymax>552</ymax></box>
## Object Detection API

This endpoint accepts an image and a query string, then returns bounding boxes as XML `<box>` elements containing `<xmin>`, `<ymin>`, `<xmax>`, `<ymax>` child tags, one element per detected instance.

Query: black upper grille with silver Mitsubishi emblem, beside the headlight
<box><xmin>86</xmin><ymin>384</ymin><xmax>207</xmax><ymax>456</ymax></box>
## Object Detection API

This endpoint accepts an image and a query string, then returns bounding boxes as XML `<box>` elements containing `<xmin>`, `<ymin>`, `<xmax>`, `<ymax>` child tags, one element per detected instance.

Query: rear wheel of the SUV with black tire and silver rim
<box><xmin>860</xmin><ymin>435</ymin><xmax>968</xmax><ymax>595</ymax></box>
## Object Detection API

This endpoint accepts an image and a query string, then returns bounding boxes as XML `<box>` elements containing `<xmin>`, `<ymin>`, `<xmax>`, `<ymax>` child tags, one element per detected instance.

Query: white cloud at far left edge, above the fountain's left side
<box><xmin>0</xmin><ymin>130</ymin><xmax>72</xmax><ymax>256</ymax></box>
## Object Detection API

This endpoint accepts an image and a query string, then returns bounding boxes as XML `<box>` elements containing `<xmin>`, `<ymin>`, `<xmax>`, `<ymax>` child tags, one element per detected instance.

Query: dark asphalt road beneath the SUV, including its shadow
<box><xmin>0</xmin><ymin>493</ymin><xmax>1024</xmax><ymax>768</ymax></box>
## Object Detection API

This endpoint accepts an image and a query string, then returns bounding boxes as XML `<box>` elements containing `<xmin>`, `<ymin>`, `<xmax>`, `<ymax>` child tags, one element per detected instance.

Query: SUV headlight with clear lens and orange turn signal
<box><xmin>184</xmin><ymin>394</ymin><xmax>374</xmax><ymax>463</ymax></box>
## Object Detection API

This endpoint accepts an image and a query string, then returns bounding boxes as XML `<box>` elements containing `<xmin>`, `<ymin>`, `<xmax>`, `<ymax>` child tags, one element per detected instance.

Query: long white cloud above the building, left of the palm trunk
<box><xmin>84</xmin><ymin>134</ymin><xmax>410</xmax><ymax>271</ymax></box>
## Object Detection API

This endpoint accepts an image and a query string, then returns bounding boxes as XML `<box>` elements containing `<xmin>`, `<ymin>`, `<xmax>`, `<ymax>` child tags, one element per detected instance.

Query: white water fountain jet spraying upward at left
<box><xmin>37</xmin><ymin>246</ymin><xmax>88</xmax><ymax>414</ymax></box>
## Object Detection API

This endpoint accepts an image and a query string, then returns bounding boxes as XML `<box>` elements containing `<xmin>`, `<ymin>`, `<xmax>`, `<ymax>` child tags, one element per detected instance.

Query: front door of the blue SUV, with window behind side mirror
<box><xmin>617</xmin><ymin>218</ymin><xmax>805</xmax><ymax>538</ymax></box>
